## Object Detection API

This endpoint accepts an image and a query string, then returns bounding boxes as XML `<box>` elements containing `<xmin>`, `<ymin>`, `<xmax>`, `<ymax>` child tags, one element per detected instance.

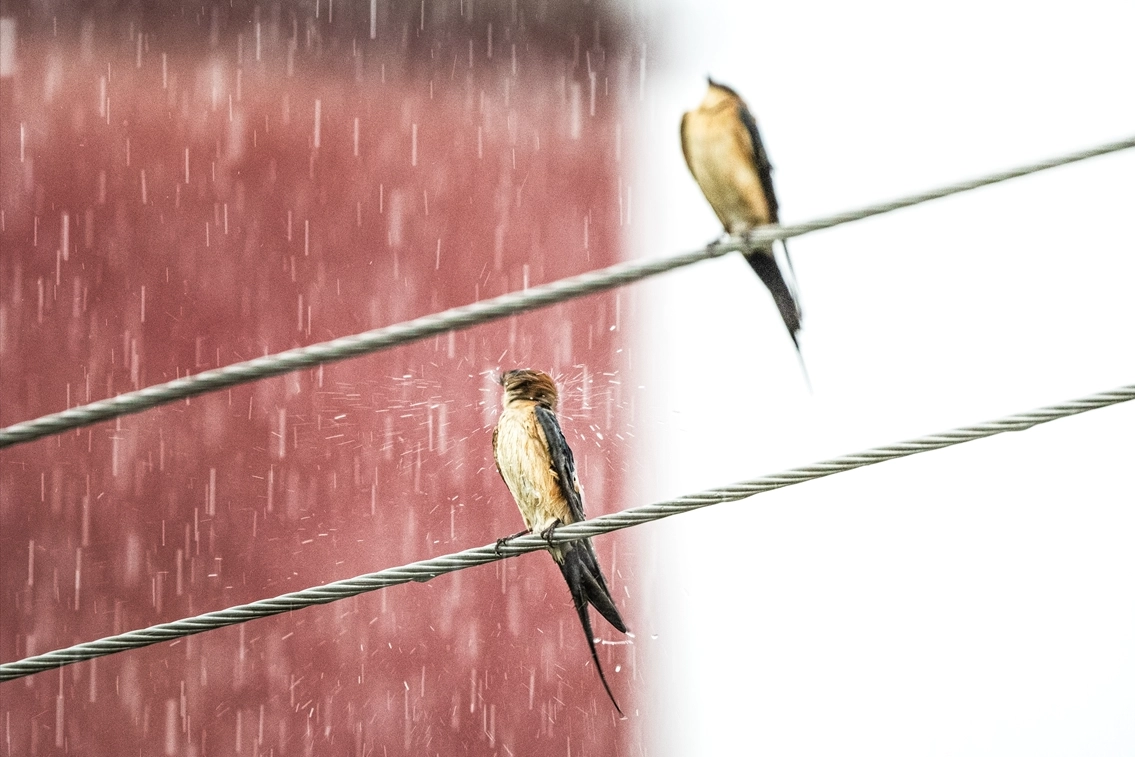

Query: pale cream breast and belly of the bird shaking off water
<box><xmin>496</xmin><ymin>404</ymin><xmax>570</xmax><ymax>533</ymax></box>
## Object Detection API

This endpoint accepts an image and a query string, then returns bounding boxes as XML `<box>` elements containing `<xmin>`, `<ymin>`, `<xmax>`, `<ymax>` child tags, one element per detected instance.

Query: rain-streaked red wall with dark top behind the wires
<box><xmin>0</xmin><ymin>2</ymin><xmax>638</xmax><ymax>755</ymax></box>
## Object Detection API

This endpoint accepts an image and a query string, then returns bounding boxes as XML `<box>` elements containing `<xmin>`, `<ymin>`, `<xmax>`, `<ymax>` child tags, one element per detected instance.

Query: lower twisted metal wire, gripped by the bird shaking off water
<box><xmin>0</xmin><ymin>384</ymin><xmax>1135</xmax><ymax>681</ymax></box>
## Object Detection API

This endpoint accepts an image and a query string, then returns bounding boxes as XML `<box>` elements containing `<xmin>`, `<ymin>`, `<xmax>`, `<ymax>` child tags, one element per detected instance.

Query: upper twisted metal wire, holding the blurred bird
<box><xmin>0</xmin><ymin>136</ymin><xmax>1135</xmax><ymax>448</ymax></box>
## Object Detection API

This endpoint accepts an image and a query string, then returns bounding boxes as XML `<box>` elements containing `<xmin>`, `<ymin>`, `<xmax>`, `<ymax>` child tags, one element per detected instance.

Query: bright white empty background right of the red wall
<box><xmin>627</xmin><ymin>0</ymin><xmax>1135</xmax><ymax>757</ymax></box>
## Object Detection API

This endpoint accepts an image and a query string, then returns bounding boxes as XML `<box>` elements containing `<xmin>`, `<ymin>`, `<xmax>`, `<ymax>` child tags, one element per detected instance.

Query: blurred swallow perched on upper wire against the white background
<box><xmin>682</xmin><ymin>78</ymin><xmax>802</xmax><ymax>364</ymax></box>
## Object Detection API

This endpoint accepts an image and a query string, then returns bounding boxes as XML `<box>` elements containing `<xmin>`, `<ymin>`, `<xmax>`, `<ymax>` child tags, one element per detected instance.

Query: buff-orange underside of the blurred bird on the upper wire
<box><xmin>682</xmin><ymin>104</ymin><xmax>768</xmax><ymax>234</ymax></box>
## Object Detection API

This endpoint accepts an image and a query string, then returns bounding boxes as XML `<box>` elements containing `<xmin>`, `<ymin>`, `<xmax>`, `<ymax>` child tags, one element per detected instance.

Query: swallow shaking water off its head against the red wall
<box><xmin>493</xmin><ymin>369</ymin><xmax>627</xmax><ymax>716</ymax></box>
